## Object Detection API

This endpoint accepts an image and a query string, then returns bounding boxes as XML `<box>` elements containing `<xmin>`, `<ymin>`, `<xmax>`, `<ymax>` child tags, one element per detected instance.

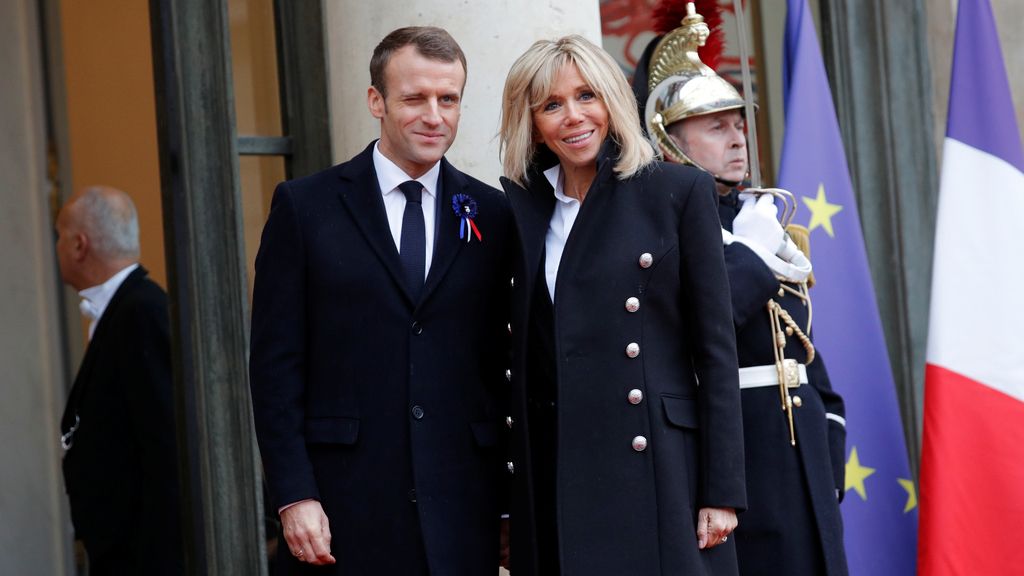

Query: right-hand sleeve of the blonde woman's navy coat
<box><xmin>679</xmin><ymin>169</ymin><xmax>746</xmax><ymax>509</ymax></box>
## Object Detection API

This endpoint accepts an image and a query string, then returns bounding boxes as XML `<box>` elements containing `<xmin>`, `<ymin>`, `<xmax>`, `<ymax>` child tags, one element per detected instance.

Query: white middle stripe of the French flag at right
<box><xmin>928</xmin><ymin>137</ymin><xmax>1024</xmax><ymax>401</ymax></box>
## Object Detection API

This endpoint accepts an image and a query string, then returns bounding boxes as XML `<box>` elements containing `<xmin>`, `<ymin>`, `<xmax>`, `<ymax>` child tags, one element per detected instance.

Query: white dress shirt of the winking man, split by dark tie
<box><xmin>374</xmin><ymin>140</ymin><xmax>441</xmax><ymax>281</ymax></box>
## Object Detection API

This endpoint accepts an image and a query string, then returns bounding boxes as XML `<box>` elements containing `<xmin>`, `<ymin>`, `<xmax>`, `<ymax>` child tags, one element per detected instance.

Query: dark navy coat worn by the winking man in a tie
<box><xmin>250</xmin><ymin>140</ymin><xmax>513</xmax><ymax>576</ymax></box>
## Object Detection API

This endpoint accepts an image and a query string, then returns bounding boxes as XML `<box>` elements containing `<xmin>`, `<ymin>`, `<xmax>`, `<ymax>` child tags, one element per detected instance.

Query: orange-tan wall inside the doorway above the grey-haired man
<box><xmin>60</xmin><ymin>0</ymin><xmax>167</xmax><ymax>286</ymax></box>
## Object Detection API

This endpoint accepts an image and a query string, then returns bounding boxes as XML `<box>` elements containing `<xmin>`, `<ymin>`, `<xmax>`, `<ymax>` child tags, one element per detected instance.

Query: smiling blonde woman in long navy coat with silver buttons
<box><xmin>501</xmin><ymin>36</ymin><xmax>745</xmax><ymax>576</ymax></box>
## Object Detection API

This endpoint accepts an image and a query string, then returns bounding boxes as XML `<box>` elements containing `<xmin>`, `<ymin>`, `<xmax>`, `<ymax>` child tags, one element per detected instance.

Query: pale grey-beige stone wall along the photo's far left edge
<box><xmin>0</xmin><ymin>0</ymin><xmax>72</xmax><ymax>575</ymax></box>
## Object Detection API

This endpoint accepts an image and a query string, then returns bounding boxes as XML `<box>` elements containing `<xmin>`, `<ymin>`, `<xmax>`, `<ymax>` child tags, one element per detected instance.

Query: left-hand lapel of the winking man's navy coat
<box><xmin>338</xmin><ymin>143</ymin><xmax>416</xmax><ymax>304</ymax></box>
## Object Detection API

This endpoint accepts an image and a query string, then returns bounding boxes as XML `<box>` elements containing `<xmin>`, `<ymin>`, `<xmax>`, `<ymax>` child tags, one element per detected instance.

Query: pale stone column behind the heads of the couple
<box><xmin>325</xmin><ymin>0</ymin><xmax>601</xmax><ymax>187</ymax></box>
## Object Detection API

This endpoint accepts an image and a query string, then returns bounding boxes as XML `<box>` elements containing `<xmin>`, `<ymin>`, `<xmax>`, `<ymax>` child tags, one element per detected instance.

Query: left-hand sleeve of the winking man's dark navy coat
<box><xmin>249</xmin><ymin>182</ymin><xmax>319</xmax><ymax>509</ymax></box>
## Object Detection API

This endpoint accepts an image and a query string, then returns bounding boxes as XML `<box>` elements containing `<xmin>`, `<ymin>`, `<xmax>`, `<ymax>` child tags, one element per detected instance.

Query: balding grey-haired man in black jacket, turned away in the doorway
<box><xmin>56</xmin><ymin>187</ymin><xmax>184</xmax><ymax>576</ymax></box>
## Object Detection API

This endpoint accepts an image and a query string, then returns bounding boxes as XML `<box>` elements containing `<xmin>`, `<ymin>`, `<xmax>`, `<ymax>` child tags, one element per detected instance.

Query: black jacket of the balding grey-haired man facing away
<box><xmin>61</xmin><ymin>266</ymin><xmax>184</xmax><ymax>575</ymax></box>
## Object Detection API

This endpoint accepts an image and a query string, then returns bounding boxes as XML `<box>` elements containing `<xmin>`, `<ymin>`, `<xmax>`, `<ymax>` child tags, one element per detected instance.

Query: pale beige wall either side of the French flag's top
<box><xmin>926</xmin><ymin>0</ymin><xmax>1024</xmax><ymax>166</ymax></box>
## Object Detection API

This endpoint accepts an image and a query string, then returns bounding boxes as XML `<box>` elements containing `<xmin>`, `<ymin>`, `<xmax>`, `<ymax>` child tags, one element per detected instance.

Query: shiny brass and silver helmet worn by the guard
<box><xmin>644</xmin><ymin>2</ymin><xmax>743</xmax><ymax>168</ymax></box>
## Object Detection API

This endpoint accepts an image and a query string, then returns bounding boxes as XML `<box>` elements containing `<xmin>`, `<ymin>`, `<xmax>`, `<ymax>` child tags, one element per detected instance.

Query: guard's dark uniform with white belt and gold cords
<box><xmin>719</xmin><ymin>191</ymin><xmax>847</xmax><ymax>576</ymax></box>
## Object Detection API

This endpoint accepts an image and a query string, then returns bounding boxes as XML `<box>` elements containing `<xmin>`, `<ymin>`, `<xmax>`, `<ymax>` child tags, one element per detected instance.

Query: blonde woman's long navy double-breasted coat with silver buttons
<box><xmin>503</xmin><ymin>143</ymin><xmax>745</xmax><ymax>576</ymax></box>
